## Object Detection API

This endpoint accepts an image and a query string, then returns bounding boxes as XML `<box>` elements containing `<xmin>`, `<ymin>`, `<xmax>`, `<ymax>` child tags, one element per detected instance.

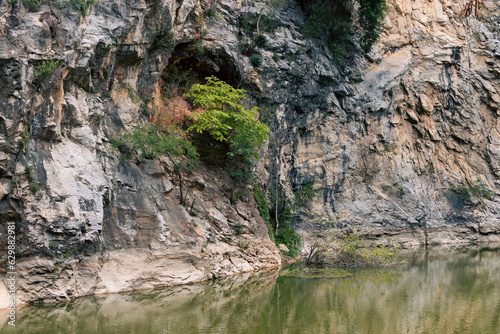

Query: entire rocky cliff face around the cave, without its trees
<box><xmin>0</xmin><ymin>0</ymin><xmax>500</xmax><ymax>308</ymax></box>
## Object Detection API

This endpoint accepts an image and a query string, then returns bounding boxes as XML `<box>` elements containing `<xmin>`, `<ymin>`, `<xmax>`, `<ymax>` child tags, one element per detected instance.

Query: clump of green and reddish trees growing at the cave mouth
<box><xmin>111</xmin><ymin>76</ymin><xmax>269</xmax><ymax>205</ymax></box>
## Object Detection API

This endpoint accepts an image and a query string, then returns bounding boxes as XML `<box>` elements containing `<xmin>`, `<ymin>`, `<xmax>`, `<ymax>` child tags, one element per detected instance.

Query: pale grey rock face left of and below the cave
<box><xmin>0</xmin><ymin>1</ymin><xmax>281</xmax><ymax>308</ymax></box>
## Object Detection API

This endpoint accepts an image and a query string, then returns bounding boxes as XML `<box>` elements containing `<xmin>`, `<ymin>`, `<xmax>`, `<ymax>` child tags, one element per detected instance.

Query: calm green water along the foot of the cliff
<box><xmin>0</xmin><ymin>247</ymin><xmax>500</xmax><ymax>334</ymax></box>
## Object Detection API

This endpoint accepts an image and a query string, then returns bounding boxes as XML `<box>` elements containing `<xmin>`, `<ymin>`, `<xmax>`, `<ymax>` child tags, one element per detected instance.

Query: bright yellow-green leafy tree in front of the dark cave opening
<box><xmin>186</xmin><ymin>76</ymin><xmax>269</xmax><ymax>164</ymax></box>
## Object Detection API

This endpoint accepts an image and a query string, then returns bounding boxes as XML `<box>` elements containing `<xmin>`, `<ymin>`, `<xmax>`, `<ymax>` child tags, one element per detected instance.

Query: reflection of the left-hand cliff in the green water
<box><xmin>0</xmin><ymin>269</ymin><xmax>278</xmax><ymax>334</ymax></box>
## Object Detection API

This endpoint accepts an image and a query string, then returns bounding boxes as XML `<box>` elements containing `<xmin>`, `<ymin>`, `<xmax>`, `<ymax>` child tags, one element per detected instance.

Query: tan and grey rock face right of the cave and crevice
<box><xmin>280</xmin><ymin>1</ymin><xmax>500</xmax><ymax>245</ymax></box>
